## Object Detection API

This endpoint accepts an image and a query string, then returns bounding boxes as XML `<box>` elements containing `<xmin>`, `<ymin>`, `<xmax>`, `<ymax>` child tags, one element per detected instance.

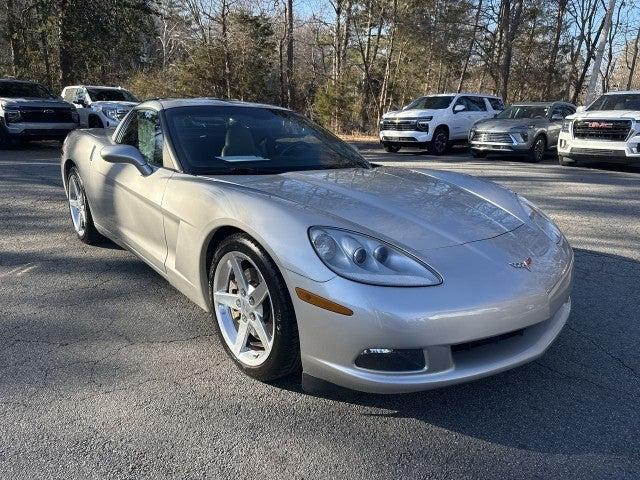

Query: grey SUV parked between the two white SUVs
<box><xmin>469</xmin><ymin>102</ymin><xmax>576</xmax><ymax>162</ymax></box>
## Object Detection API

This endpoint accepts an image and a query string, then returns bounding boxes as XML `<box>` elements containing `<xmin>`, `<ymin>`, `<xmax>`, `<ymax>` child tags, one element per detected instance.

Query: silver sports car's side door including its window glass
<box><xmin>95</xmin><ymin>108</ymin><xmax>174</xmax><ymax>271</ymax></box>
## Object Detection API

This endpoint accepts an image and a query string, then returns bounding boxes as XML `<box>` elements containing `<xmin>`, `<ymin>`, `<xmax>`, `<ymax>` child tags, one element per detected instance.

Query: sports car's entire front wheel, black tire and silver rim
<box><xmin>209</xmin><ymin>234</ymin><xmax>300</xmax><ymax>382</ymax></box>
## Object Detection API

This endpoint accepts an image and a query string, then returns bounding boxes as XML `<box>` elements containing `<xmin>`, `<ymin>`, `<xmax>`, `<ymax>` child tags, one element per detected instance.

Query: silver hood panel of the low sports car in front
<box><xmin>211</xmin><ymin>167</ymin><xmax>522</xmax><ymax>252</ymax></box>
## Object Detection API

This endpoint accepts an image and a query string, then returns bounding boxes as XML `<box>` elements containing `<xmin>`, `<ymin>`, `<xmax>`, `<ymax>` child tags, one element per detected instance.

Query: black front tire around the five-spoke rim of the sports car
<box><xmin>209</xmin><ymin>233</ymin><xmax>301</xmax><ymax>382</ymax></box>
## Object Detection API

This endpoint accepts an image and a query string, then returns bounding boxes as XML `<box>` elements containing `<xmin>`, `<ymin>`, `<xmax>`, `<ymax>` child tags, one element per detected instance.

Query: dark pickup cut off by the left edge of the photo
<box><xmin>0</xmin><ymin>78</ymin><xmax>78</xmax><ymax>146</ymax></box>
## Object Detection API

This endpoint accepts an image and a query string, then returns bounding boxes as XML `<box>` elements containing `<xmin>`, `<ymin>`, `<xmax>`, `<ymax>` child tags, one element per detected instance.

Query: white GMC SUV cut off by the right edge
<box><xmin>558</xmin><ymin>91</ymin><xmax>640</xmax><ymax>165</ymax></box>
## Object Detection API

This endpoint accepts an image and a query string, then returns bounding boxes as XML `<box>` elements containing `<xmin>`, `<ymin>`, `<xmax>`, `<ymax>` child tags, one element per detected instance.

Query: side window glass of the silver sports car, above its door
<box><xmin>119</xmin><ymin>110</ymin><xmax>164</xmax><ymax>167</ymax></box>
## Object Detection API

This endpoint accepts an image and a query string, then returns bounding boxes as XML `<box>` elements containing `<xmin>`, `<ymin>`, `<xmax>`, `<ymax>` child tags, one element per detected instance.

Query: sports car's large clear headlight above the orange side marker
<box><xmin>309</xmin><ymin>227</ymin><xmax>442</xmax><ymax>287</ymax></box>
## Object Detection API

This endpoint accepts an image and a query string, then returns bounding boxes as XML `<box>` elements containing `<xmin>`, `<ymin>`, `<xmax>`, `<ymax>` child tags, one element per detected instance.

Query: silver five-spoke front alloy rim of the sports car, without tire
<box><xmin>213</xmin><ymin>251</ymin><xmax>275</xmax><ymax>367</ymax></box>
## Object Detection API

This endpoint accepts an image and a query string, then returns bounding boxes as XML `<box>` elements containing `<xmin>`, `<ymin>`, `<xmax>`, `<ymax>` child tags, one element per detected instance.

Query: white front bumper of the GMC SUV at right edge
<box><xmin>558</xmin><ymin>132</ymin><xmax>640</xmax><ymax>164</ymax></box>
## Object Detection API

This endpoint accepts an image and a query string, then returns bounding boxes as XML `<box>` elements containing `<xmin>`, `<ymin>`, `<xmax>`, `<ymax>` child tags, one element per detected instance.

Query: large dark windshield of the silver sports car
<box><xmin>165</xmin><ymin>105</ymin><xmax>371</xmax><ymax>175</ymax></box>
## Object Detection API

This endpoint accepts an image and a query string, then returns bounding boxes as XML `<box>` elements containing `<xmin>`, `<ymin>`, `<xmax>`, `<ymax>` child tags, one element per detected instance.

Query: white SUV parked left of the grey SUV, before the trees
<box><xmin>380</xmin><ymin>93</ymin><xmax>504</xmax><ymax>155</ymax></box>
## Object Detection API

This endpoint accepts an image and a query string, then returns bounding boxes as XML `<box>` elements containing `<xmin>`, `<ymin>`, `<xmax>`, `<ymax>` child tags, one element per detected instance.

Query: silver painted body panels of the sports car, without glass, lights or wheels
<box><xmin>62</xmin><ymin>99</ymin><xmax>573</xmax><ymax>393</ymax></box>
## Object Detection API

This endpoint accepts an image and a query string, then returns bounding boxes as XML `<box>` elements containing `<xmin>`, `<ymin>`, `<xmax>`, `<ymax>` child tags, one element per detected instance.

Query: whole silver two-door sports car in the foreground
<box><xmin>62</xmin><ymin>99</ymin><xmax>573</xmax><ymax>393</ymax></box>
